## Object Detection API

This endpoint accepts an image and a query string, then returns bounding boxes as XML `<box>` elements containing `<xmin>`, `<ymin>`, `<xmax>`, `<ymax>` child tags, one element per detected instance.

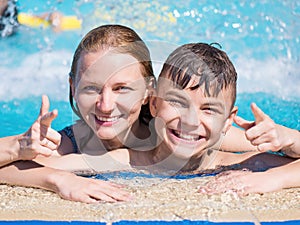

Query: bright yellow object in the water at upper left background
<box><xmin>18</xmin><ymin>13</ymin><xmax>82</xmax><ymax>30</ymax></box>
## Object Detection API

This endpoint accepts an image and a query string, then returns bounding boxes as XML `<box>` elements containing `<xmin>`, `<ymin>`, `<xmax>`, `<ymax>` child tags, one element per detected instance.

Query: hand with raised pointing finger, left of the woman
<box><xmin>19</xmin><ymin>95</ymin><xmax>61</xmax><ymax>160</ymax></box>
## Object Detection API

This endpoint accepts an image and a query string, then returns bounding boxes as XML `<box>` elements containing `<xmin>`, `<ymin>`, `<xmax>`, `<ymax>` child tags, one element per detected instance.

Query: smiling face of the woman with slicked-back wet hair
<box><xmin>72</xmin><ymin>51</ymin><xmax>147</xmax><ymax>140</ymax></box>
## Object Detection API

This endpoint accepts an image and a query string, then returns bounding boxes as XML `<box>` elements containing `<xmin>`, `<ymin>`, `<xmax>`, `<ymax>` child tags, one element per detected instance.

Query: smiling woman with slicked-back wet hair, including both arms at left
<box><xmin>0</xmin><ymin>25</ymin><xmax>154</xmax><ymax>203</ymax></box>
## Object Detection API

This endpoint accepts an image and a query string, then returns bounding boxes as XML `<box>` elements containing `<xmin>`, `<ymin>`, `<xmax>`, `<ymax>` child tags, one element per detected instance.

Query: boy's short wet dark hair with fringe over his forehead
<box><xmin>159</xmin><ymin>43</ymin><xmax>237</xmax><ymax>107</ymax></box>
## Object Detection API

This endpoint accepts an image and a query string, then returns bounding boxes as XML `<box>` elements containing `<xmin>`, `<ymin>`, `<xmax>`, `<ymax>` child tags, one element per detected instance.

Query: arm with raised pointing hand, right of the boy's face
<box><xmin>221</xmin><ymin>103</ymin><xmax>300</xmax><ymax>158</ymax></box>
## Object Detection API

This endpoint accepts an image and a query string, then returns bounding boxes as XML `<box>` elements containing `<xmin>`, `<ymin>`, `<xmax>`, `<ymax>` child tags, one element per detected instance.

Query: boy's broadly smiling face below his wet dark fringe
<box><xmin>150</xmin><ymin>77</ymin><xmax>236</xmax><ymax>159</ymax></box>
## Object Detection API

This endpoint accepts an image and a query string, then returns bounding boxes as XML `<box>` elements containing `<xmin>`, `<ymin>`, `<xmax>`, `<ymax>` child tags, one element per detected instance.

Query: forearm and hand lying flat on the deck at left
<box><xmin>0</xmin><ymin>161</ymin><xmax>130</xmax><ymax>203</ymax></box>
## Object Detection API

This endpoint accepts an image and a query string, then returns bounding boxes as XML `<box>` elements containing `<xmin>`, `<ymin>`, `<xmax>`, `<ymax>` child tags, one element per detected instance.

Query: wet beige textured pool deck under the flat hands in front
<box><xmin>0</xmin><ymin>177</ymin><xmax>300</xmax><ymax>224</ymax></box>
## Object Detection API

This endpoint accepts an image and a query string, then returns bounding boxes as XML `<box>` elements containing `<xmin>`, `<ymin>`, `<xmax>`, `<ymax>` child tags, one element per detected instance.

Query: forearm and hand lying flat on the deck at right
<box><xmin>199</xmin><ymin>159</ymin><xmax>300</xmax><ymax>194</ymax></box>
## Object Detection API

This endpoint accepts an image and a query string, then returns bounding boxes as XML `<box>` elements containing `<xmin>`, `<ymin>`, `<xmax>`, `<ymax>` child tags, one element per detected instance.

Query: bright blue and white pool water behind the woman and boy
<box><xmin>0</xmin><ymin>0</ymin><xmax>300</xmax><ymax>136</ymax></box>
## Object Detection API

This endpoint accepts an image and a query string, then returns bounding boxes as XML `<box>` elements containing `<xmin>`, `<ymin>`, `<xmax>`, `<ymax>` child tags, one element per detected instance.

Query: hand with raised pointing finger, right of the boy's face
<box><xmin>234</xmin><ymin>103</ymin><xmax>289</xmax><ymax>152</ymax></box>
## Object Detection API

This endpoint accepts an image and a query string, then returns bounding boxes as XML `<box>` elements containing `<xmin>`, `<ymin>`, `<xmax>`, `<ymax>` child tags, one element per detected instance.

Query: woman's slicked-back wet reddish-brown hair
<box><xmin>69</xmin><ymin>25</ymin><xmax>155</xmax><ymax>124</ymax></box>
